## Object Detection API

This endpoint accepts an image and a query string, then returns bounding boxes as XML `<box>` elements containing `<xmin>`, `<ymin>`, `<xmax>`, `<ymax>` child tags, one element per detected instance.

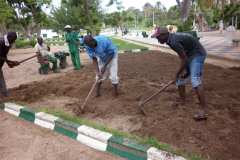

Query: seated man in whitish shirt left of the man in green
<box><xmin>34</xmin><ymin>37</ymin><xmax>59</xmax><ymax>74</ymax></box>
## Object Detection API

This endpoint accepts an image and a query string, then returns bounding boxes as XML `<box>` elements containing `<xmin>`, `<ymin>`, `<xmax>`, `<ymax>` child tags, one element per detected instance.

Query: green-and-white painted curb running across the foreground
<box><xmin>0</xmin><ymin>103</ymin><xmax>186</xmax><ymax>160</ymax></box>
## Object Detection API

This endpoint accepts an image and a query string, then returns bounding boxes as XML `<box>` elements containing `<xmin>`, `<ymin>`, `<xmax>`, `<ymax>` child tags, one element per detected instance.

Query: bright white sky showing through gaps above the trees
<box><xmin>50</xmin><ymin>0</ymin><xmax>177</xmax><ymax>13</ymax></box>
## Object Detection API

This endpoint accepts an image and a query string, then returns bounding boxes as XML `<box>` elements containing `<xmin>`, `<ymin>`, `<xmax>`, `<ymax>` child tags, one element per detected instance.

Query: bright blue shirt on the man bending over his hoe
<box><xmin>86</xmin><ymin>36</ymin><xmax>117</xmax><ymax>63</ymax></box>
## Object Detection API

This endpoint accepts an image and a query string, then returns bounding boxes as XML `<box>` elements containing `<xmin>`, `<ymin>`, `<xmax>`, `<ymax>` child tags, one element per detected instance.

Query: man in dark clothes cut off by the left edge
<box><xmin>0</xmin><ymin>32</ymin><xmax>19</xmax><ymax>97</ymax></box>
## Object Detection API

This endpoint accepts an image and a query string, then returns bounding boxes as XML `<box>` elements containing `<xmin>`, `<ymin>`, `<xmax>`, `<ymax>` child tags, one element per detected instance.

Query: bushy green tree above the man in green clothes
<box><xmin>52</xmin><ymin>0</ymin><xmax>102</xmax><ymax>34</ymax></box>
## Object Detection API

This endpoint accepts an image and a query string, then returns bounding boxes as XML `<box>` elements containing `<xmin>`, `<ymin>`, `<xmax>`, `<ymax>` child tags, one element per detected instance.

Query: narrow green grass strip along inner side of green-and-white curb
<box><xmin>39</xmin><ymin>107</ymin><xmax>204</xmax><ymax>160</ymax></box>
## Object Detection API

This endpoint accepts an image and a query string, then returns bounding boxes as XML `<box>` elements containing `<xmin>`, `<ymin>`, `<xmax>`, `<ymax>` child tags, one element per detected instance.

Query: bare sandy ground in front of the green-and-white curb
<box><xmin>0</xmin><ymin>111</ymin><xmax>124</xmax><ymax>160</ymax></box>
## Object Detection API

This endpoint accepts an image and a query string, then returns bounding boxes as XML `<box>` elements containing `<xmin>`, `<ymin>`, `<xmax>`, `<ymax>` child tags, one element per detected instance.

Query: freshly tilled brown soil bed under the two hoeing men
<box><xmin>2</xmin><ymin>51</ymin><xmax>240</xmax><ymax>160</ymax></box>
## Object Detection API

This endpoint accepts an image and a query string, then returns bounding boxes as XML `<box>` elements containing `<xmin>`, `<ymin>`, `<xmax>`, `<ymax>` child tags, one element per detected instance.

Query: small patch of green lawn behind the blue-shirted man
<box><xmin>110</xmin><ymin>37</ymin><xmax>146</xmax><ymax>50</ymax></box>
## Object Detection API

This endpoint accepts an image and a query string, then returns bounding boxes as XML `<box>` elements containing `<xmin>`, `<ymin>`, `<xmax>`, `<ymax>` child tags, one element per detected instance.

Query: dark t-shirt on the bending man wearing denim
<box><xmin>167</xmin><ymin>33</ymin><xmax>207</xmax><ymax>60</ymax></box>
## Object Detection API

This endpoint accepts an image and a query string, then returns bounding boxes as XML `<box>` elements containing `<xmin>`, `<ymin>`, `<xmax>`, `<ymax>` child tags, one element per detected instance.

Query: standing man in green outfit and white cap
<box><xmin>64</xmin><ymin>25</ymin><xmax>81</xmax><ymax>70</ymax></box>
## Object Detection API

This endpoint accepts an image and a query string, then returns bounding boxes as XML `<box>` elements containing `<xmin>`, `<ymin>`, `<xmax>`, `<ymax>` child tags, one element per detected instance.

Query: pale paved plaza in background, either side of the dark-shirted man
<box><xmin>122</xmin><ymin>32</ymin><xmax>240</xmax><ymax>60</ymax></box>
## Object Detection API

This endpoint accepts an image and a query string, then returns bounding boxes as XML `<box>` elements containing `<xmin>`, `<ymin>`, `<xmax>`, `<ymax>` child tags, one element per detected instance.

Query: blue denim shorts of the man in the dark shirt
<box><xmin>176</xmin><ymin>56</ymin><xmax>206</xmax><ymax>88</ymax></box>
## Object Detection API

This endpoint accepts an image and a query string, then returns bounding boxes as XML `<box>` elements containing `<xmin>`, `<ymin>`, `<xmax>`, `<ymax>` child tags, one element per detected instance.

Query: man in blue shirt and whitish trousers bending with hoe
<box><xmin>84</xmin><ymin>35</ymin><xmax>119</xmax><ymax>97</ymax></box>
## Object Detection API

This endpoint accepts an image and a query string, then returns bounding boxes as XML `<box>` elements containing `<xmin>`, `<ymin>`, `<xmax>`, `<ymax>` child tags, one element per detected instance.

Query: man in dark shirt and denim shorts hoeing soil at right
<box><xmin>152</xmin><ymin>27</ymin><xmax>207</xmax><ymax>120</ymax></box>
